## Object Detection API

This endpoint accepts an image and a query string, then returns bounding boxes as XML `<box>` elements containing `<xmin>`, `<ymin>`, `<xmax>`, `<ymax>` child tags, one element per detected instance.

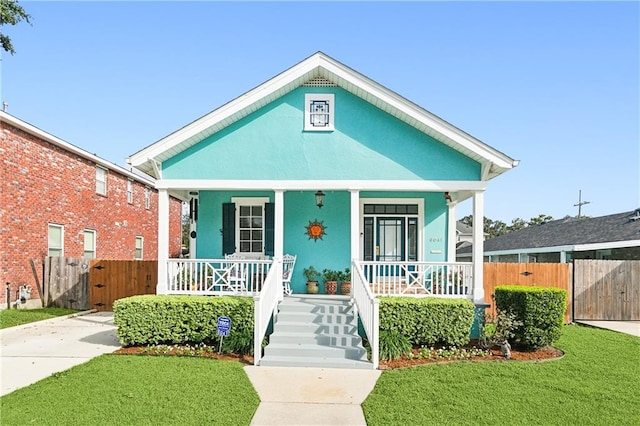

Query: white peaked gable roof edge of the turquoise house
<box><xmin>128</xmin><ymin>52</ymin><xmax>518</xmax><ymax>180</ymax></box>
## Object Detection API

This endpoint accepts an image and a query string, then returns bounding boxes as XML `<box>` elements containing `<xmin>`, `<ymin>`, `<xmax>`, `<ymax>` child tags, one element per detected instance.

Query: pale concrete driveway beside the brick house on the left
<box><xmin>0</xmin><ymin>312</ymin><xmax>120</xmax><ymax>395</ymax></box>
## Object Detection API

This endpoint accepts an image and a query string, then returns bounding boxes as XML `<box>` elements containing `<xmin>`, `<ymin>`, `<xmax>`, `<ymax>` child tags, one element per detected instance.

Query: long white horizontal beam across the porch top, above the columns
<box><xmin>156</xmin><ymin>179</ymin><xmax>487</xmax><ymax>192</ymax></box>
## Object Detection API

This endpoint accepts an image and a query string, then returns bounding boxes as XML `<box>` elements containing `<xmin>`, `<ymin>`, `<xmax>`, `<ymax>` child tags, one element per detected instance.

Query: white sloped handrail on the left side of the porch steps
<box><xmin>253</xmin><ymin>259</ymin><xmax>283</xmax><ymax>365</ymax></box>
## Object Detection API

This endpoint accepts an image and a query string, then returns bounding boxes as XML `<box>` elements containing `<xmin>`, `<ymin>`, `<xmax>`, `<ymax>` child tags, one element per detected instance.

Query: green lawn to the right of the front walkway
<box><xmin>363</xmin><ymin>326</ymin><xmax>640</xmax><ymax>425</ymax></box>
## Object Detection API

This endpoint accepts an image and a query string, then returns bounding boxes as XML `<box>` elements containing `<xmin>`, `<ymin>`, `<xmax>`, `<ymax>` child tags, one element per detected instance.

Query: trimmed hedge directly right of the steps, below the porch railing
<box><xmin>380</xmin><ymin>297</ymin><xmax>475</xmax><ymax>346</ymax></box>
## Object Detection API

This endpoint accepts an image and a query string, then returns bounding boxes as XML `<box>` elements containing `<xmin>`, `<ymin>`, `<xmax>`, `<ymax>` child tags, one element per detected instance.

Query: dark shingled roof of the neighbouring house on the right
<box><xmin>458</xmin><ymin>209</ymin><xmax>640</xmax><ymax>255</ymax></box>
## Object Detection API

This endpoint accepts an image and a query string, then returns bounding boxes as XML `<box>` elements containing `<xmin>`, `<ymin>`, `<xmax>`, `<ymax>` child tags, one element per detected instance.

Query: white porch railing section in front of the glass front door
<box><xmin>358</xmin><ymin>261</ymin><xmax>473</xmax><ymax>299</ymax></box>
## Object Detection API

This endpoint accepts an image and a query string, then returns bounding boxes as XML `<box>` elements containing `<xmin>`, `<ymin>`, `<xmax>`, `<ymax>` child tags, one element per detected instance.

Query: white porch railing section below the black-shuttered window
<box><xmin>167</xmin><ymin>259</ymin><xmax>272</xmax><ymax>296</ymax></box>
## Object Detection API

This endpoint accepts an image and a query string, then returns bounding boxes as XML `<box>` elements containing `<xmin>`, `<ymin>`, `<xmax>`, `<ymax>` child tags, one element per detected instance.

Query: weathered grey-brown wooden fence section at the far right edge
<box><xmin>573</xmin><ymin>260</ymin><xmax>640</xmax><ymax>321</ymax></box>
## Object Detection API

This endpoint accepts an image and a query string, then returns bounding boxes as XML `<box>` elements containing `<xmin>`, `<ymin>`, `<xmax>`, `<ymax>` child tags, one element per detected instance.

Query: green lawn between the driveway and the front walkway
<box><xmin>0</xmin><ymin>355</ymin><xmax>259</xmax><ymax>426</ymax></box>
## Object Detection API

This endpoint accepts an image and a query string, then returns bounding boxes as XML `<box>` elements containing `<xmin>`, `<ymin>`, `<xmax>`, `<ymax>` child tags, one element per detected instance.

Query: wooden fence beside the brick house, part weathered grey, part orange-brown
<box><xmin>44</xmin><ymin>256</ymin><xmax>158</xmax><ymax>311</ymax></box>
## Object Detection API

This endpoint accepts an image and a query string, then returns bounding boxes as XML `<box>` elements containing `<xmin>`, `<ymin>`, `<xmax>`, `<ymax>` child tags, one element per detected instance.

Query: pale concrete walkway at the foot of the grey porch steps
<box><xmin>245</xmin><ymin>366</ymin><xmax>381</xmax><ymax>426</ymax></box>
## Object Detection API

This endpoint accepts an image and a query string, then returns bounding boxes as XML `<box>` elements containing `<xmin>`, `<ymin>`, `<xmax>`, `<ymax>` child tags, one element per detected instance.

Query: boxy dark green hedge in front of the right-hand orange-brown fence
<box><xmin>495</xmin><ymin>285</ymin><xmax>568</xmax><ymax>349</ymax></box>
